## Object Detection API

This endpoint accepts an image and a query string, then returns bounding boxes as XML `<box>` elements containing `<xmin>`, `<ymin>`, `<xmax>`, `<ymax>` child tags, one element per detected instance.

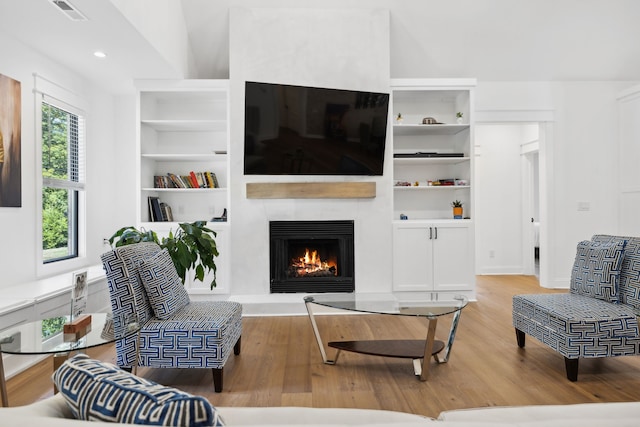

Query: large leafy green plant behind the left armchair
<box><xmin>109</xmin><ymin>221</ymin><xmax>219</xmax><ymax>289</ymax></box>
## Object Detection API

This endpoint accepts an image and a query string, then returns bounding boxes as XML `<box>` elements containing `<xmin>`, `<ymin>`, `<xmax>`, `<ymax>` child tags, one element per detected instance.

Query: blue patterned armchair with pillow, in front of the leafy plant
<box><xmin>102</xmin><ymin>243</ymin><xmax>242</xmax><ymax>392</ymax></box>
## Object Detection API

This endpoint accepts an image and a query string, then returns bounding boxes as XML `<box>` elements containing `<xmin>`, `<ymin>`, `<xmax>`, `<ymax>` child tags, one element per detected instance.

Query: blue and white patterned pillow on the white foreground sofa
<box><xmin>53</xmin><ymin>354</ymin><xmax>224</xmax><ymax>427</ymax></box>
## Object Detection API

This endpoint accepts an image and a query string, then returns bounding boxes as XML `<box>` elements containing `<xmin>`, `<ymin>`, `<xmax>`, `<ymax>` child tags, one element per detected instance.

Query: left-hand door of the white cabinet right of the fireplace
<box><xmin>393</xmin><ymin>224</ymin><xmax>433</xmax><ymax>291</ymax></box>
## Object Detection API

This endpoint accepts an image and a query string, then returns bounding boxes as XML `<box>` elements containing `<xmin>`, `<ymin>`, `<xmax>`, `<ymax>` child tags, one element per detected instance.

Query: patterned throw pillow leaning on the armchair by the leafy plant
<box><xmin>139</xmin><ymin>249</ymin><xmax>190</xmax><ymax>319</ymax></box>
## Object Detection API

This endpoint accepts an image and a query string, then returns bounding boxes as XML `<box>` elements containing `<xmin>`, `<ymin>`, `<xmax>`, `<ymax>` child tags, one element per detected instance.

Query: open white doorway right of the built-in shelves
<box><xmin>475</xmin><ymin>121</ymin><xmax>546</xmax><ymax>278</ymax></box>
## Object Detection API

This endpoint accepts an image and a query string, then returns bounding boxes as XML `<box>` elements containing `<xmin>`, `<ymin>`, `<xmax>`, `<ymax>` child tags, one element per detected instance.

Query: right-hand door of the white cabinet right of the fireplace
<box><xmin>433</xmin><ymin>226</ymin><xmax>473</xmax><ymax>291</ymax></box>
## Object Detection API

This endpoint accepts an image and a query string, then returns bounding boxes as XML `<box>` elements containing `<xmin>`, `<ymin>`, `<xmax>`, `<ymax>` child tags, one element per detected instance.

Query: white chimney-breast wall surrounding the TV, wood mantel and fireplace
<box><xmin>225</xmin><ymin>9</ymin><xmax>392</xmax><ymax>301</ymax></box>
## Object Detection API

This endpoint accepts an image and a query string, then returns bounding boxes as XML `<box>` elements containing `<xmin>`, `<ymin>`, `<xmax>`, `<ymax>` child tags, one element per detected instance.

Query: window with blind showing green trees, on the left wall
<box><xmin>41</xmin><ymin>97</ymin><xmax>84</xmax><ymax>264</ymax></box>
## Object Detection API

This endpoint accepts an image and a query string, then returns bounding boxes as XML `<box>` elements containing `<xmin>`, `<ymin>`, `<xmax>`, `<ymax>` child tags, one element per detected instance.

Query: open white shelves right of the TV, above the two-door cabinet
<box><xmin>391</xmin><ymin>79</ymin><xmax>475</xmax><ymax>220</ymax></box>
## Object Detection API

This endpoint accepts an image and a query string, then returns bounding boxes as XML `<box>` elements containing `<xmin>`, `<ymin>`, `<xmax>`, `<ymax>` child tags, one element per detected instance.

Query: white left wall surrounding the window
<box><xmin>0</xmin><ymin>33</ymin><xmax>125</xmax><ymax>289</ymax></box>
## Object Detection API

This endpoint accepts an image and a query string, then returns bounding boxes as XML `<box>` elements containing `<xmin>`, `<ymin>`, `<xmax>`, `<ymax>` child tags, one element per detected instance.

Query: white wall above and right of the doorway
<box><xmin>476</xmin><ymin>82</ymin><xmax>632</xmax><ymax>288</ymax></box>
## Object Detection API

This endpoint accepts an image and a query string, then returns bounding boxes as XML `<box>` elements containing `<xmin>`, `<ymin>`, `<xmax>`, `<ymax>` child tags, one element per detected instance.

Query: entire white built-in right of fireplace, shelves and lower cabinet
<box><xmin>391</xmin><ymin>79</ymin><xmax>475</xmax><ymax>298</ymax></box>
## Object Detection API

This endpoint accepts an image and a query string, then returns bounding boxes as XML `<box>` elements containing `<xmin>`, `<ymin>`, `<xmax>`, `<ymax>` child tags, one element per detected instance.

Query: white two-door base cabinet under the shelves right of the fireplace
<box><xmin>393</xmin><ymin>221</ymin><xmax>475</xmax><ymax>297</ymax></box>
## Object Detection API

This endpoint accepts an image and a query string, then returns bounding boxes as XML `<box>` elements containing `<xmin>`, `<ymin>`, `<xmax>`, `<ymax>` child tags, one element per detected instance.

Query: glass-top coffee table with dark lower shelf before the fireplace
<box><xmin>304</xmin><ymin>292</ymin><xmax>468</xmax><ymax>381</ymax></box>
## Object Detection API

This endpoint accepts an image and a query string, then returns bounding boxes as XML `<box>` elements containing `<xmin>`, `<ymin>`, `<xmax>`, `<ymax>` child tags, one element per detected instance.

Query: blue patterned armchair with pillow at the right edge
<box><xmin>513</xmin><ymin>235</ymin><xmax>640</xmax><ymax>381</ymax></box>
